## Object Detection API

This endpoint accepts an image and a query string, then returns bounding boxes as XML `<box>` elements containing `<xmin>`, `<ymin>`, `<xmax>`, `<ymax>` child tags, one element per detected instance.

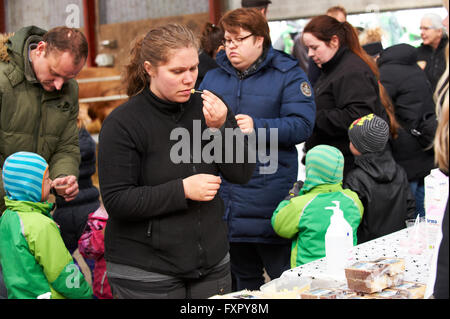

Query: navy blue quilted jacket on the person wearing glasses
<box><xmin>200</xmin><ymin>47</ymin><xmax>316</xmax><ymax>243</ymax></box>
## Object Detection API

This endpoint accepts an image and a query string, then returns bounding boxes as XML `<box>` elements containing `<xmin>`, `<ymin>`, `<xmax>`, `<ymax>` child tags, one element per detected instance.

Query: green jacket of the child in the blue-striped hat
<box><xmin>0</xmin><ymin>198</ymin><xmax>92</xmax><ymax>299</ymax></box>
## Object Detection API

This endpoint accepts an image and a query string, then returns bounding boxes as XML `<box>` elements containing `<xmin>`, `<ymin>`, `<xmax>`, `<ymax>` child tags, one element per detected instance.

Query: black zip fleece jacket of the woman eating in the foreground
<box><xmin>98</xmin><ymin>88</ymin><xmax>255</xmax><ymax>278</ymax></box>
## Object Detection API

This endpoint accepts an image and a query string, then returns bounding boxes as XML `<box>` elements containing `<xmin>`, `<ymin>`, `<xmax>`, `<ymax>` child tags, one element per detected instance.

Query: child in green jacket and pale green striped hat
<box><xmin>272</xmin><ymin>145</ymin><xmax>364</xmax><ymax>268</ymax></box>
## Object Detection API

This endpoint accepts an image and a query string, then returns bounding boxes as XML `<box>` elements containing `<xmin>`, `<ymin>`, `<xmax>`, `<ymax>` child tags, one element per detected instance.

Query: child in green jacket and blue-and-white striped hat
<box><xmin>0</xmin><ymin>152</ymin><xmax>92</xmax><ymax>299</ymax></box>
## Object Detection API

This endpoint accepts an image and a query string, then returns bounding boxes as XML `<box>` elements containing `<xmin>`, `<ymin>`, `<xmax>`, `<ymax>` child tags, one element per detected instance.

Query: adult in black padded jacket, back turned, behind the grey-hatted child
<box><xmin>377</xmin><ymin>44</ymin><xmax>436</xmax><ymax>216</ymax></box>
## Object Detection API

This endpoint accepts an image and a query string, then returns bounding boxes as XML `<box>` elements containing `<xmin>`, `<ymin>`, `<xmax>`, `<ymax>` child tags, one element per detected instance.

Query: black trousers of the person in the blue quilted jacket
<box><xmin>230</xmin><ymin>243</ymin><xmax>291</xmax><ymax>291</ymax></box>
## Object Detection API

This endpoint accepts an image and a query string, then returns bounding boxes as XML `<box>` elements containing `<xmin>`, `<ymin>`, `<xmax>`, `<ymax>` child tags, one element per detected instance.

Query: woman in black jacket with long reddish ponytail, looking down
<box><xmin>303</xmin><ymin>15</ymin><xmax>387</xmax><ymax>179</ymax></box>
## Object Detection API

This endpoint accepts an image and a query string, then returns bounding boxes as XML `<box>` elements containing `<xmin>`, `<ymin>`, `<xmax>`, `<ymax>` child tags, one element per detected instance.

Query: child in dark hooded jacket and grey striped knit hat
<box><xmin>344</xmin><ymin>114</ymin><xmax>416</xmax><ymax>244</ymax></box>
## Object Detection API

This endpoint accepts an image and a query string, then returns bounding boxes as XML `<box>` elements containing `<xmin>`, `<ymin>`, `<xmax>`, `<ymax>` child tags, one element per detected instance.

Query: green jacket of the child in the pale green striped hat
<box><xmin>272</xmin><ymin>183</ymin><xmax>364</xmax><ymax>268</ymax></box>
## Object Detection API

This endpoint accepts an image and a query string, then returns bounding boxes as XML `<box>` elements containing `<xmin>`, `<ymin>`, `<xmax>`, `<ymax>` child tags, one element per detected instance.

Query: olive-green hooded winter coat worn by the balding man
<box><xmin>0</xmin><ymin>26</ymin><xmax>80</xmax><ymax>212</ymax></box>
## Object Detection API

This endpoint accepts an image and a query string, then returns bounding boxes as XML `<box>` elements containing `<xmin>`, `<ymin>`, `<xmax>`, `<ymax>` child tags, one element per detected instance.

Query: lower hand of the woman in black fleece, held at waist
<box><xmin>183</xmin><ymin>174</ymin><xmax>222</xmax><ymax>202</ymax></box>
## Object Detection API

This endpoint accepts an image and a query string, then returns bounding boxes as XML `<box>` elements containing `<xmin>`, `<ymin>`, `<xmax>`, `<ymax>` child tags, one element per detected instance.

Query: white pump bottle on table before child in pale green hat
<box><xmin>325</xmin><ymin>201</ymin><xmax>353</xmax><ymax>280</ymax></box>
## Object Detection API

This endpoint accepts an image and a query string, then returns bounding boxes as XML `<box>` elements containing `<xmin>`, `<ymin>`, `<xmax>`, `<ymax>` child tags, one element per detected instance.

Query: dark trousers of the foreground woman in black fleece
<box><xmin>108</xmin><ymin>263</ymin><xmax>231</xmax><ymax>299</ymax></box>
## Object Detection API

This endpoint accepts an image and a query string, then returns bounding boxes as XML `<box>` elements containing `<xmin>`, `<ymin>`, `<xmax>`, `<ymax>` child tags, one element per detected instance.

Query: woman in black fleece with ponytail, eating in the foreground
<box><xmin>98</xmin><ymin>25</ymin><xmax>255</xmax><ymax>299</ymax></box>
